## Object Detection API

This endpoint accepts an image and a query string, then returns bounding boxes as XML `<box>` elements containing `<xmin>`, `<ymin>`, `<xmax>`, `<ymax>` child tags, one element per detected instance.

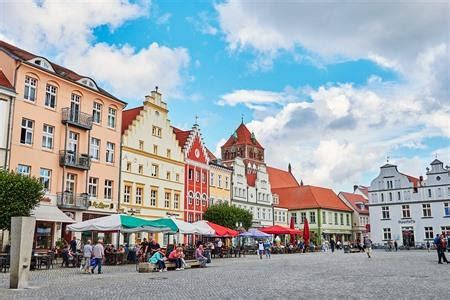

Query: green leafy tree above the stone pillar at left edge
<box><xmin>0</xmin><ymin>170</ymin><xmax>44</xmax><ymax>230</ymax></box>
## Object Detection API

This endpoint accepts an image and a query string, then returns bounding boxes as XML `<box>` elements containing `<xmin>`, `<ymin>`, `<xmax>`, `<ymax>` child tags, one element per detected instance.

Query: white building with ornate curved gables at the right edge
<box><xmin>369</xmin><ymin>159</ymin><xmax>450</xmax><ymax>247</ymax></box>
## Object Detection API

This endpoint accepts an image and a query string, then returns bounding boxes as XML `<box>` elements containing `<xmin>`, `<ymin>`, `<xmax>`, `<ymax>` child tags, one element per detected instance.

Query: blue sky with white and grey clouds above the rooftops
<box><xmin>0</xmin><ymin>0</ymin><xmax>450</xmax><ymax>192</ymax></box>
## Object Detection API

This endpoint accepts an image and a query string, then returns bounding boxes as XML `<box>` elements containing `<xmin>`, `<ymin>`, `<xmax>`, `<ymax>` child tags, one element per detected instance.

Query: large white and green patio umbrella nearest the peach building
<box><xmin>67</xmin><ymin>214</ymin><xmax>171</xmax><ymax>232</ymax></box>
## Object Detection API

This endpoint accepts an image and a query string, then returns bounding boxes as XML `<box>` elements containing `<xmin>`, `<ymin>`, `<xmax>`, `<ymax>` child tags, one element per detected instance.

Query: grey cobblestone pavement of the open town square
<box><xmin>0</xmin><ymin>251</ymin><xmax>450</xmax><ymax>300</ymax></box>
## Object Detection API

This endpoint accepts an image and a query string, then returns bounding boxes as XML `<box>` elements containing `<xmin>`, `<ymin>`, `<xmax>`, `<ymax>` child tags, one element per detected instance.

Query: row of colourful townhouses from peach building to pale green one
<box><xmin>0</xmin><ymin>41</ymin><xmax>370</xmax><ymax>249</ymax></box>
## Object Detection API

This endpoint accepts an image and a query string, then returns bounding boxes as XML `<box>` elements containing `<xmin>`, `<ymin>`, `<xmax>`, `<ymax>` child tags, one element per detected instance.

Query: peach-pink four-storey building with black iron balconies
<box><xmin>0</xmin><ymin>41</ymin><xmax>126</xmax><ymax>248</ymax></box>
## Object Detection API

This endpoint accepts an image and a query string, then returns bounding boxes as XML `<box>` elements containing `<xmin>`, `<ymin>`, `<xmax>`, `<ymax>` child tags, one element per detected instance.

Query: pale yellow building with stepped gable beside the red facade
<box><xmin>120</xmin><ymin>91</ymin><xmax>184</xmax><ymax>244</ymax></box>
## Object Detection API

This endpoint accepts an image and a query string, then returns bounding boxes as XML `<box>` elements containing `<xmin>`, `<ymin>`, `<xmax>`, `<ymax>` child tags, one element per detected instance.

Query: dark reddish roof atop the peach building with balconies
<box><xmin>0</xmin><ymin>40</ymin><xmax>127</xmax><ymax>104</ymax></box>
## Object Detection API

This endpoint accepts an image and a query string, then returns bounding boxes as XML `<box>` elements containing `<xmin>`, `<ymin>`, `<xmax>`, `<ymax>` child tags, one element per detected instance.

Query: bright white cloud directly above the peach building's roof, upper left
<box><xmin>0</xmin><ymin>0</ymin><xmax>189</xmax><ymax>100</ymax></box>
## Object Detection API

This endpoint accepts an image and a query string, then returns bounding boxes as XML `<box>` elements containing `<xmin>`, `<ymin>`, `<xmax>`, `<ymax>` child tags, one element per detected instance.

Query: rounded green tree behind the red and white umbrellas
<box><xmin>203</xmin><ymin>203</ymin><xmax>253</xmax><ymax>229</ymax></box>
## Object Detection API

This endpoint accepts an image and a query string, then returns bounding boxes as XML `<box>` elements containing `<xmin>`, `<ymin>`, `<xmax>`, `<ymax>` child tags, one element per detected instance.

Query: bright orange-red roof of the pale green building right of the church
<box><xmin>272</xmin><ymin>185</ymin><xmax>352</xmax><ymax>211</ymax></box>
